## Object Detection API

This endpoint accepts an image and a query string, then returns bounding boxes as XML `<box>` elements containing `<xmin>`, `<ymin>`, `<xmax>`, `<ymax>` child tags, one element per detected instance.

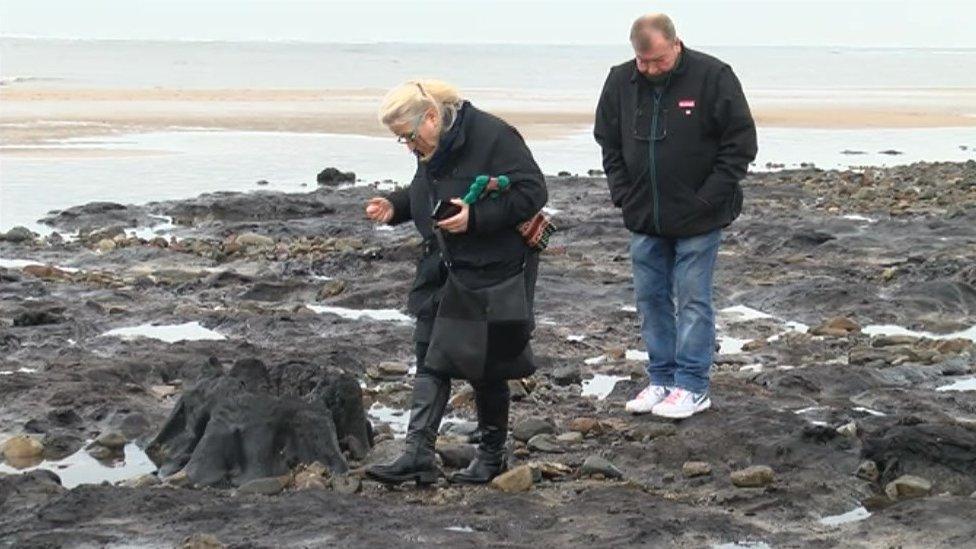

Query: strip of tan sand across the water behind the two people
<box><xmin>0</xmin><ymin>85</ymin><xmax>976</xmax><ymax>158</ymax></box>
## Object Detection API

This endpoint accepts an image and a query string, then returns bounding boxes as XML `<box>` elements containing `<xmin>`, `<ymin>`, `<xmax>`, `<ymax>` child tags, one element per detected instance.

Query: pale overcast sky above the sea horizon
<box><xmin>0</xmin><ymin>0</ymin><xmax>976</xmax><ymax>48</ymax></box>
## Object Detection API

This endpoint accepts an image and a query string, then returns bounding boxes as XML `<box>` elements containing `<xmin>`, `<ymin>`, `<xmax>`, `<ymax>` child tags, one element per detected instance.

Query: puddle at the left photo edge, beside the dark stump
<box><xmin>0</xmin><ymin>444</ymin><xmax>156</xmax><ymax>488</ymax></box>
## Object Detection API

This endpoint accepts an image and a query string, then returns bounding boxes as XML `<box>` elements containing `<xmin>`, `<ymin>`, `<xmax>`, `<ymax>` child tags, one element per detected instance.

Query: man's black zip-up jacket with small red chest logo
<box><xmin>593</xmin><ymin>45</ymin><xmax>757</xmax><ymax>238</ymax></box>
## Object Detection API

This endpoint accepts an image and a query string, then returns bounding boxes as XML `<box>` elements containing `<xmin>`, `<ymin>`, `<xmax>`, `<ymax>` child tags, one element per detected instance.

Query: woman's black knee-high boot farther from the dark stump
<box><xmin>451</xmin><ymin>380</ymin><xmax>510</xmax><ymax>484</ymax></box>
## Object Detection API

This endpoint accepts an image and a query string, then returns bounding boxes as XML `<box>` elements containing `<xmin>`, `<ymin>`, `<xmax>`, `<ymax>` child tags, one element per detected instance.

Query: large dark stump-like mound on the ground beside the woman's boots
<box><xmin>147</xmin><ymin>359</ymin><xmax>372</xmax><ymax>486</ymax></box>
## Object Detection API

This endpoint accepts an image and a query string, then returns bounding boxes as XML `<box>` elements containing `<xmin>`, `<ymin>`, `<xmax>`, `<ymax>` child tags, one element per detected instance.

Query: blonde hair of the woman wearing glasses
<box><xmin>379</xmin><ymin>80</ymin><xmax>462</xmax><ymax>128</ymax></box>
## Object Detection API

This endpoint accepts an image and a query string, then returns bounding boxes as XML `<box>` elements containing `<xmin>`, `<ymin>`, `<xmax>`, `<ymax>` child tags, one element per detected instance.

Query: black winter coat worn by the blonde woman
<box><xmin>387</xmin><ymin>102</ymin><xmax>548</xmax><ymax>342</ymax></box>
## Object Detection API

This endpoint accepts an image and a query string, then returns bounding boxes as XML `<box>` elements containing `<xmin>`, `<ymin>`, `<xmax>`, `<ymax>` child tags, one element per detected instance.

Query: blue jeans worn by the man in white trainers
<box><xmin>630</xmin><ymin>230</ymin><xmax>722</xmax><ymax>393</ymax></box>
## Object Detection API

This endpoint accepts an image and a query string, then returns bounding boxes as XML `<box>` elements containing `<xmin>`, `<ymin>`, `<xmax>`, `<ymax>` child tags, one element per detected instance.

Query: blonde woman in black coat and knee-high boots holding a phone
<box><xmin>366</xmin><ymin>80</ymin><xmax>547</xmax><ymax>484</ymax></box>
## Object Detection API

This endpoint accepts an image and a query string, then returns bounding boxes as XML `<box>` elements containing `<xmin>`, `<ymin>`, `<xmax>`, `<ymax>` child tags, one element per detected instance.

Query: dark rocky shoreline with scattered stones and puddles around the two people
<box><xmin>0</xmin><ymin>161</ymin><xmax>976</xmax><ymax>547</ymax></box>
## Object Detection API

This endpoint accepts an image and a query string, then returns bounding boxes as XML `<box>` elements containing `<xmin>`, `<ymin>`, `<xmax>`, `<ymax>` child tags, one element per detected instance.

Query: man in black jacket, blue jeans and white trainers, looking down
<box><xmin>593</xmin><ymin>14</ymin><xmax>757</xmax><ymax>418</ymax></box>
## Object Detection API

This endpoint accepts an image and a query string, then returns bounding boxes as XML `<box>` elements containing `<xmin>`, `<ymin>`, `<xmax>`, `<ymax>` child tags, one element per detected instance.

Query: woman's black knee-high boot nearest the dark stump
<box><xmin>366</xmin><ymin>370</ymin><xmax>451</xmax><ymax>485</ymax></box>
